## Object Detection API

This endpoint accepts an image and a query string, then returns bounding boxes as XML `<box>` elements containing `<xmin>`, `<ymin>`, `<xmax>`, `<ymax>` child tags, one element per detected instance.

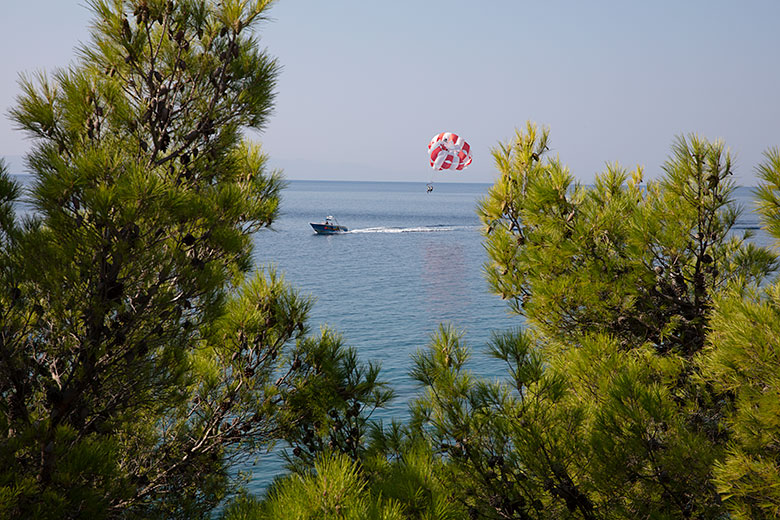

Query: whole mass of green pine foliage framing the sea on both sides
<box><xmin>9</xmin><ymin>0</ymin><xmax>780</xmax><ymax>519</ymax></box>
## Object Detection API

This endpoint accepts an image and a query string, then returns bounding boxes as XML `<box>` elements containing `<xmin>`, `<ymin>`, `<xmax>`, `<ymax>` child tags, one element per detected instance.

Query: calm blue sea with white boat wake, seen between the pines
<box><xmin>6</xmin><ymin>179</ymin><xmax>772</xmax><ymax>495</ymax></box>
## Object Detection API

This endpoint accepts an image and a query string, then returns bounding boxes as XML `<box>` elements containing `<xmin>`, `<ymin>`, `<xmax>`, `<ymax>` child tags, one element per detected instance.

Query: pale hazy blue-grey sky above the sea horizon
<box><xmin>0</xmin><ymin>0</ymin><xmax>780</xmax><ymax>186</ymax></box>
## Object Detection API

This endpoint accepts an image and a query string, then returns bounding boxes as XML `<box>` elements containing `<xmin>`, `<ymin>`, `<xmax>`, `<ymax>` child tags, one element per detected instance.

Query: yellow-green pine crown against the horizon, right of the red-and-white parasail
<box><xmin>479</xmin><ymin>124</ymin><xmax>775</xmax><ymax>357</ymax></box>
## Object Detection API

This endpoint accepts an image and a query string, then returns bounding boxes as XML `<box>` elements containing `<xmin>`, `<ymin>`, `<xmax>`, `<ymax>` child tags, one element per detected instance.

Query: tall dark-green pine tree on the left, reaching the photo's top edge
<box><xmin>0</xmin><ymin>0</ymin><xmax>362</xmax><ymax>518</ymax></box>
